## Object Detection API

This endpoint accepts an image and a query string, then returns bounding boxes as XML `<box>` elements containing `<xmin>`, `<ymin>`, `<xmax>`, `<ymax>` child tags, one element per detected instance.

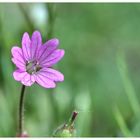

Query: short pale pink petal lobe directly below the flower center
<box><xmin>21</xmin><ymin>72</ymin><xmax>35</xmax><ymax>86</ymax></box>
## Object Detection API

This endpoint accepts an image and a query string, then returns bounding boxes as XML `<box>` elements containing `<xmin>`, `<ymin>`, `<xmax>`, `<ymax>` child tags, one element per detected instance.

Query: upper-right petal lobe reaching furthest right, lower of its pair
<box><xmin>40</xmin><ymin>49</ymin><xmax>65</xmax><ymax>67</ymax></box>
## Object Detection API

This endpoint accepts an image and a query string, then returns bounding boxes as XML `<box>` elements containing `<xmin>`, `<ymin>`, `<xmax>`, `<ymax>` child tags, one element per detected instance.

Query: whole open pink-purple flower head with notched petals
<box><xmin>11</xmin><ymin>31</ymin><xmax>65</xmax><ymax>88</ymax></box>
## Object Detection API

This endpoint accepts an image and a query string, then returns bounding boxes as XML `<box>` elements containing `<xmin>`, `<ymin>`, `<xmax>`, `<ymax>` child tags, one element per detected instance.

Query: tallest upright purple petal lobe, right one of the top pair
<box><xmin>31</xmin><ymin>31</ymin><xmax>42</xmax><ymax>59</ymax></box>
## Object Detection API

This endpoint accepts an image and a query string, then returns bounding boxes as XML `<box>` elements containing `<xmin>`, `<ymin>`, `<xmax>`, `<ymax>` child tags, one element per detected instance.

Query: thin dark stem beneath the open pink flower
<box><xmin>18</xmin><ymin>85</ymin><xmax>25</xmax><ymax>135</ymax></box>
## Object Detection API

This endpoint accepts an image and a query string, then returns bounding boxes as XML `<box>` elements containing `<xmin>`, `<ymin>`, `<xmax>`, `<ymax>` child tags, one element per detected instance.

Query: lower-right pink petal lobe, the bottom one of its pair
<box><xmin>33</xmin><ymin>72</ymin><xmax>56</xmax><ymax>88</ymax></box>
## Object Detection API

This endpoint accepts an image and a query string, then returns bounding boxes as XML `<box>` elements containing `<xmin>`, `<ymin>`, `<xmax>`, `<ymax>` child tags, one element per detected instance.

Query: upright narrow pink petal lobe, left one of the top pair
<box><xmin>22</xmin><ymin>32</ymin><xmax>31</xmax><ymax>61</ymax></box>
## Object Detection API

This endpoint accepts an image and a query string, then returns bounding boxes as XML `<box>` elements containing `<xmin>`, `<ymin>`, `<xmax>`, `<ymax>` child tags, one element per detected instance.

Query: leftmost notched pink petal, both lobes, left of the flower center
<box><xmin>11</xmin><ymin>47</ymin><xmax>26</xmax><ymax>70</ymax></box>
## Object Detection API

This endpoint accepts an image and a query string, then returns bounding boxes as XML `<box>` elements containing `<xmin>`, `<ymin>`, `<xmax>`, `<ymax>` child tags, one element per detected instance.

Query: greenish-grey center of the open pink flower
<box><xmin>26</xmin><ymin>61</ymin><xmax>41</xmax><ymax>74</ymax></box>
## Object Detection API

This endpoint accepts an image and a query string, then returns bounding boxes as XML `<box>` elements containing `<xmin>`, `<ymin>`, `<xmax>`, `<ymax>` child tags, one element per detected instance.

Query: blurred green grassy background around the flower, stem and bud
<box><xmin>0</xmin><ymin>3</ymin><xmax>140</xmax><ymax>137</ymax></box>
